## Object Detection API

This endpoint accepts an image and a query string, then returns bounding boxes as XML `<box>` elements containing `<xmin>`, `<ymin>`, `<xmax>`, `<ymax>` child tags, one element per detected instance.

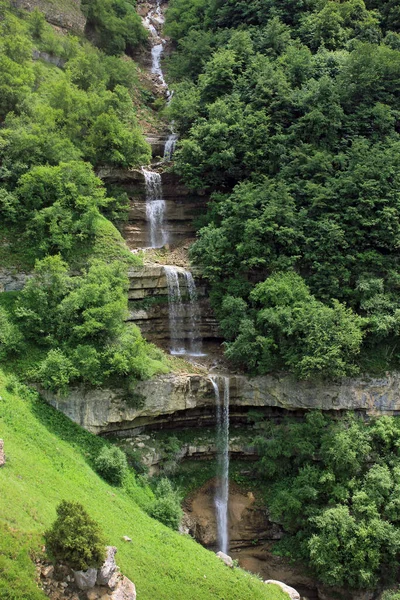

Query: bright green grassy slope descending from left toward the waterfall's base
<box><xmin>0</xmin><ymin>371</ymin><xmax>286</xmax><ymax>600</ymax></box>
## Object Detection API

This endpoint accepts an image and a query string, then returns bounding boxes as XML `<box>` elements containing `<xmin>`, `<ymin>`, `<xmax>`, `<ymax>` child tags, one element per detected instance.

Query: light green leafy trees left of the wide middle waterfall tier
<box><xmin>14</xmin><ymin>255</ymin><xmax>168</xmax><ymax>393</ymax></box>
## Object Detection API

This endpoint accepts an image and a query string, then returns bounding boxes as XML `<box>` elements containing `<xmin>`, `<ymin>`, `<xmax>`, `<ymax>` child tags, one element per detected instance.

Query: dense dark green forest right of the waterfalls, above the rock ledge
<box><xmin>167</xmin><ymin>0</ymin><xmax>400</xmax><ymax>378</ymax></box>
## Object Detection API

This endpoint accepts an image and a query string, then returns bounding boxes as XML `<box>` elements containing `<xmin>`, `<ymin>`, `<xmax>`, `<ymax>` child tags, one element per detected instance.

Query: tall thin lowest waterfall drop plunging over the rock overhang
<box><xmin>210</xmin><ymin>377</ymin><xmax>229</xmax><ymax>554</ymax></box>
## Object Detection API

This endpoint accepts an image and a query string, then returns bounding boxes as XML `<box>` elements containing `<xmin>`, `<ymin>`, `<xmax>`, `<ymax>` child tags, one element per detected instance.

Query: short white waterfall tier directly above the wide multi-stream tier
<box><xmin>142</xmin><ymin>167</ymin><xmax>168</xmax><ymax>248</ymax></box>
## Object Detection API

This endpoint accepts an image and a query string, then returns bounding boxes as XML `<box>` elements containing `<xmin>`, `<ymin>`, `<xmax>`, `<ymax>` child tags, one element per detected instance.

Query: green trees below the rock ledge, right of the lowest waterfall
<box><xmin>257</xmin><ymin>412</ymin><xmax>400</xmax><ymax>589</ymax></box>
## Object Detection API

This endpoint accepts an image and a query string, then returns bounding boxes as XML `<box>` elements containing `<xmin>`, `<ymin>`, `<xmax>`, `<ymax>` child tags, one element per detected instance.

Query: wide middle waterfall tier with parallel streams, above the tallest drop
<box><xmin>164</xmin><ymin>266</ymin><xmax>204</xmax><ymax>356</ymax></box>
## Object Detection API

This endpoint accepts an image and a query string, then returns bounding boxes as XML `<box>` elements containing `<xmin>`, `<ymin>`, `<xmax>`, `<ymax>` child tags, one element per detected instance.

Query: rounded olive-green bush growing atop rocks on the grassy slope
<box><xmin>45</xmin><ymin>500</ymin><xmax>105</xmax><ymax>571</ymax></box>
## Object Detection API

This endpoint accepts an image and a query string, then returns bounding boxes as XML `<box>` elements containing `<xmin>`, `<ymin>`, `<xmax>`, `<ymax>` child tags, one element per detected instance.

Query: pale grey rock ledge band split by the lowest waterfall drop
<box><xmin>43</xmin><ymin>373</ymin><xmax>400</xmax><ymax>436</ymax></box>
